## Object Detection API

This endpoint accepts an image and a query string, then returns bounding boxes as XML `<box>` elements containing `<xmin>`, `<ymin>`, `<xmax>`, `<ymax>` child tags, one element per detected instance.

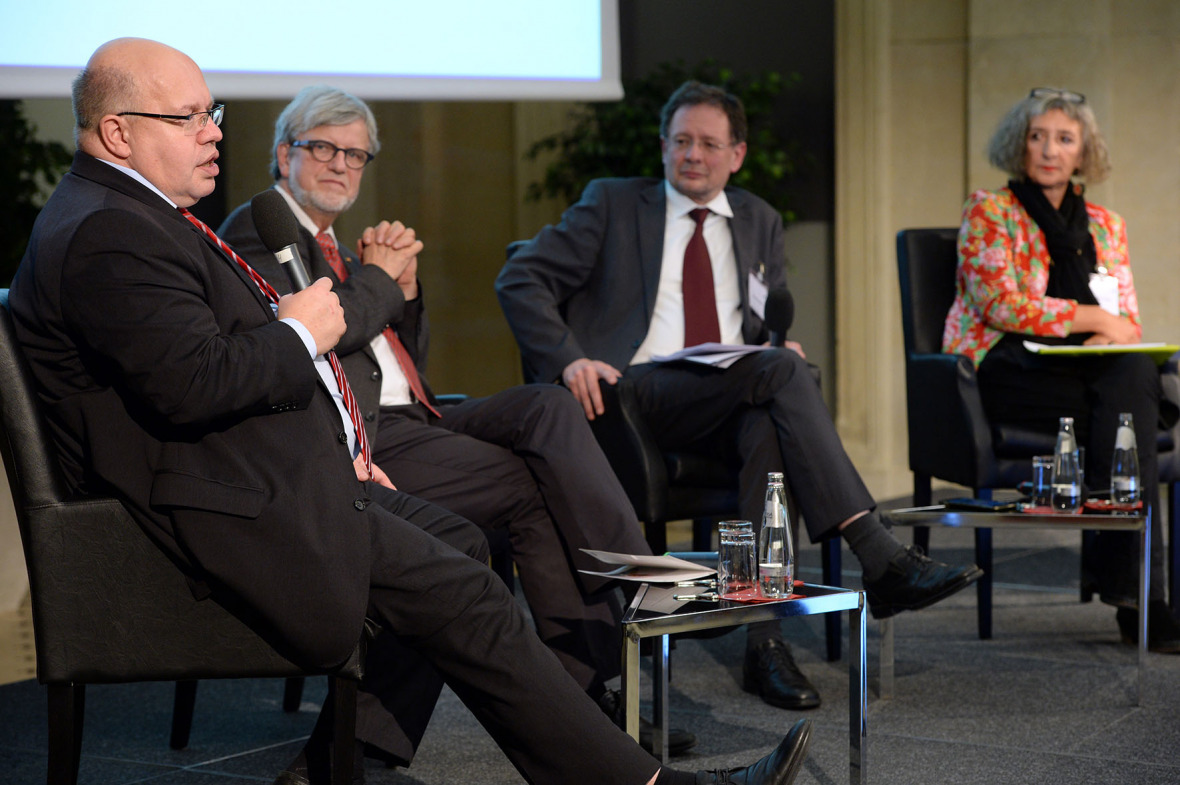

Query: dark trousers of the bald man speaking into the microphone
<box><xmin>358</xmin><ymin>488</ymin><xmax>658</xmax><ymax>785</ymax></box>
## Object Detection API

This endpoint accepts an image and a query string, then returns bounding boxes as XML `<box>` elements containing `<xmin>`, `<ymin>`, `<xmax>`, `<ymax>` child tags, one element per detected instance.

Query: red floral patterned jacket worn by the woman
<box><xmin>943</xmin><ymin>188</ymin><xmax>1140</xmax><ymax>367</ymax></box>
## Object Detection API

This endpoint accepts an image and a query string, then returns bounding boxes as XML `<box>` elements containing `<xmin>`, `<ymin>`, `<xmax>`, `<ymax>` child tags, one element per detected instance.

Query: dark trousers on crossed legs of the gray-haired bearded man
<box><xmin>374</xmin><ymin>385</ymin><xmax>650</xmax><ymax>691</ymax></box>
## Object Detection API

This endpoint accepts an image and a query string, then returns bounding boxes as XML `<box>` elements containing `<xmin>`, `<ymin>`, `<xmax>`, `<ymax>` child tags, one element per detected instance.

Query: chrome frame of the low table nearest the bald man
<box><xmin>622</xmin><ymin>583</ymin><xmax>867</xmax><ymax>785</ymax></box>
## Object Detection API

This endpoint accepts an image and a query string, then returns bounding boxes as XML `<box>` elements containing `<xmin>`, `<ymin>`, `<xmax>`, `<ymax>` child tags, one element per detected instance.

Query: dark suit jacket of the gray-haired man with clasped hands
<box><xmin>217</xmin><ymin>195</ymin><xmax>437</xmax><ymax>444</ymax></box>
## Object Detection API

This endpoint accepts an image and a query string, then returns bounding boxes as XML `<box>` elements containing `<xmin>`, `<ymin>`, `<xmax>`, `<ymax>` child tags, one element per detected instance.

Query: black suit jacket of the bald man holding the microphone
<box><xmin>9</xmin><ymin>152</ymin><xmax>372</xmax><ymax>667</ymax></box>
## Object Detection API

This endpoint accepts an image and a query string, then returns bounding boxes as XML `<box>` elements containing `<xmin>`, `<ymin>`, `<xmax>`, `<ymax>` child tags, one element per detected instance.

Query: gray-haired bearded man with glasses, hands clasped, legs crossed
<box><xmin>218</xmin><ymin>85</ymin><xmax>695</xmax><ymax>761</ymax></box>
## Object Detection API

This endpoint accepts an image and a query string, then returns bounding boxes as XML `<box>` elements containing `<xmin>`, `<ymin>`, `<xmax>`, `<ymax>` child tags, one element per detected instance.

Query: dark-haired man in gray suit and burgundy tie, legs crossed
<box><xmin>496</xmin><ymin>81</ymin><xmax>982</xmax><ymax>708</ymax></box>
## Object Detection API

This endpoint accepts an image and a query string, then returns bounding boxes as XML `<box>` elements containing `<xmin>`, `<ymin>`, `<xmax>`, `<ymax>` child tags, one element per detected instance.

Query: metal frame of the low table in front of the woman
<box><xmin>880</xmin><ymin>504</ymin><xmax>1152</xmax><ymax>706</ymax></box>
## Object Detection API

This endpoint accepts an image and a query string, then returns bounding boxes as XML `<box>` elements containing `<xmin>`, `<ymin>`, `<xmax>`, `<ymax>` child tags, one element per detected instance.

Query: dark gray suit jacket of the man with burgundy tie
<box><xmin>496</xmin><ymin>177</ymin><xmax>786</xmax><ymax>381</ymax></box>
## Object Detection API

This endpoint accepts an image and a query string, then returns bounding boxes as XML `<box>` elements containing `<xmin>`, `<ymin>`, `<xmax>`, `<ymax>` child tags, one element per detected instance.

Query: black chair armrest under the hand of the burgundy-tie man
<box><xmin>590</xmin><ymin>379</ymin><xmax>668</xmax><ymax>522</ymax></box>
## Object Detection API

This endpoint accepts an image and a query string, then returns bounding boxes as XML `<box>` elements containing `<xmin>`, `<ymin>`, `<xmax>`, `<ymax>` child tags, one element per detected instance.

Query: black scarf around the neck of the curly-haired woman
<box><xmin>1008</xmin><ymin>179</ymin><xmax>1099</xmax><ymax>306</ymax></box>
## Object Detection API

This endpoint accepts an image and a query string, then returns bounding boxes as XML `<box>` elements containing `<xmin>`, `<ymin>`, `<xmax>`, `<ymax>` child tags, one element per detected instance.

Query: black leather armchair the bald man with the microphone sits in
<box><xmin>0</xmin><ymin>289</ymin><xmax>362</xmax><ymax>785</ymax></box>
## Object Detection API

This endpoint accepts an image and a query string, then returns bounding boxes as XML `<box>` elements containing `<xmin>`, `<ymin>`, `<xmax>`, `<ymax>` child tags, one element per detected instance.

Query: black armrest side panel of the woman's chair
<box><xmin>905</xmin><ymin>354</ymin><xmax>994</xmax><ymax>488</ymax></box>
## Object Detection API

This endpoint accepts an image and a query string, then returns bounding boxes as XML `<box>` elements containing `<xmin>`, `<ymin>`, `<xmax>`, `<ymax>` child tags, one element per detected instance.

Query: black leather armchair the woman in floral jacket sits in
<box><xmin>897</xmin><ymin>228</ymin><xmax>1180</xmax><ymax>637</ymax></box>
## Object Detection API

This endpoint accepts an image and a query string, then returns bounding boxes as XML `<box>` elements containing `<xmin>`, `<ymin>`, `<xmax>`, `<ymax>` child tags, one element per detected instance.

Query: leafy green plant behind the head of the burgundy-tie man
<box><xmin>525</xmin><ymin>60</ymin><xmax>799</xmax><ymax>223</ymax></box>
